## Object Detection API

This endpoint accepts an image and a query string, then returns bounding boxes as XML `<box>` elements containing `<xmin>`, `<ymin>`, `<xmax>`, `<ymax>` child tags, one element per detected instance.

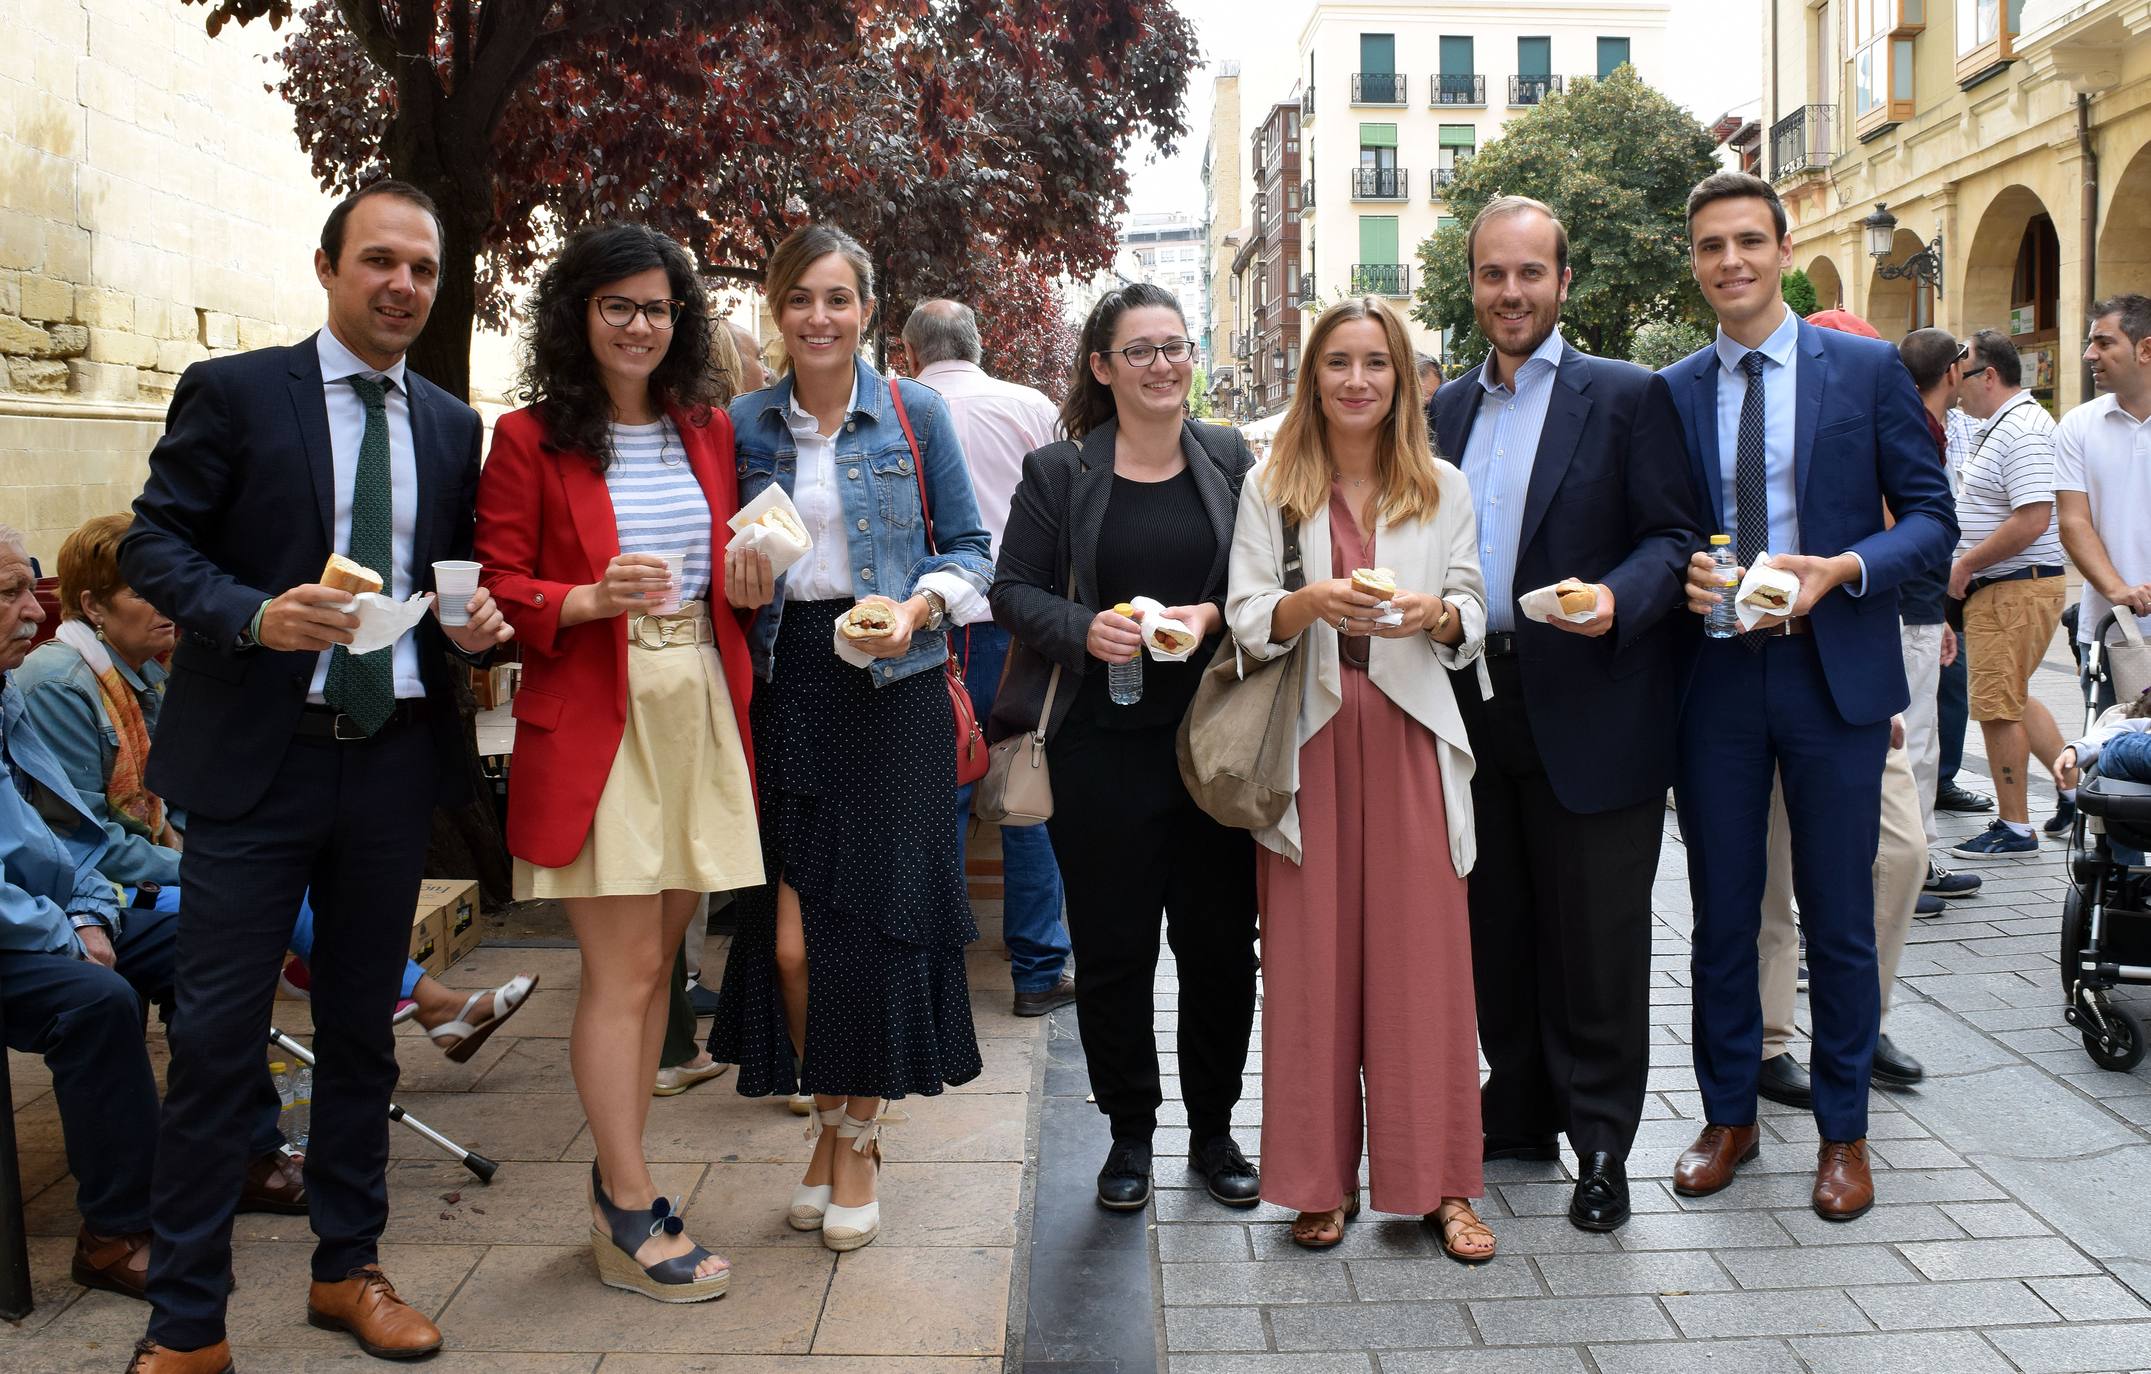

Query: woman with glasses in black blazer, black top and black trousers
<box><xmin>992</xmin><ymin>284</ymin><xmax>1260</xmax><ymax>1211</ymax></box>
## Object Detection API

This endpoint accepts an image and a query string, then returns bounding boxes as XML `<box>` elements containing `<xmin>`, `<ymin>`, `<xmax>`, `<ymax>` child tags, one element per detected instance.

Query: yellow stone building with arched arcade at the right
<box><xmin>1762</xmin><ymin>0</ymin><xmax>2151</xmax><ymax>411</ymax></box>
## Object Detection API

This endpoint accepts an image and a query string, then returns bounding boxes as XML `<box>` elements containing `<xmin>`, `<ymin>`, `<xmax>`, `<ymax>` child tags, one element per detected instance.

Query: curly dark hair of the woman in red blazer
<box><xmin>516</xmin><ymin>224</ymin><xmax>716</xmax><ymax>473</ymax></box>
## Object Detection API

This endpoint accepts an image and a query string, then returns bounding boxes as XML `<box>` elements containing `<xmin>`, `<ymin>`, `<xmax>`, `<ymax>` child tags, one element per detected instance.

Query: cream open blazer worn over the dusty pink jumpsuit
<box><xmin>1224</xmin><ymin>462</ymin><xmax>1493</xmax><ymax>877</ymax></box>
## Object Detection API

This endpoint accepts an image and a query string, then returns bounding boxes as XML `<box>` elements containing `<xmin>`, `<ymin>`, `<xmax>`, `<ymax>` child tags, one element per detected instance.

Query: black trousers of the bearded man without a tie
<box><xmin>1456</xmin><ymin>658</ymin><xmax>1671</xmax><ymax>1159</ymax></box>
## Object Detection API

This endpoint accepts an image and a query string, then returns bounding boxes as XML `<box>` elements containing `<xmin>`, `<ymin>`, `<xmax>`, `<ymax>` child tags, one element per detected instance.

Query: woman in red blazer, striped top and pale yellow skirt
<box><xmin>478</xmin><ymin>224</ymin><xmax>761</xmax><ymax>1303</ymax></box>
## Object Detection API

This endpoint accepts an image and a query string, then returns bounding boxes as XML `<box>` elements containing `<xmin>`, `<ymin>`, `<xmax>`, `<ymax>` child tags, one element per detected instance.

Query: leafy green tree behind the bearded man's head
<box><xmin>1413</xmin><ymin>67</ymin><xmax>1719</xmax><ymax>359</ymax></box>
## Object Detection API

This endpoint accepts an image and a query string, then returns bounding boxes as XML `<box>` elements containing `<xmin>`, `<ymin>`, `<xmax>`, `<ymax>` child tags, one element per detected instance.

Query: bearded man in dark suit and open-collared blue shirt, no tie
<box><xmin>1433</xmin><ymin>196</ymin><xmax>1701</xmax><ymax>1230</ymax></box>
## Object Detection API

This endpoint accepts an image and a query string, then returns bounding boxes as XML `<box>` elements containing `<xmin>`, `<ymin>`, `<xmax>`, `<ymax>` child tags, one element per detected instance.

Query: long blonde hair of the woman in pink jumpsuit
<box><xmin>1263</xmin><ymin>297</ymin><xmax>1441</xmax><ymax>525</ymax></box>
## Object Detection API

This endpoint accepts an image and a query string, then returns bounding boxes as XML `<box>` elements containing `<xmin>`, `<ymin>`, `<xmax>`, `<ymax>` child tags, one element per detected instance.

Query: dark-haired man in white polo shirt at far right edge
<box><xmin>2054</xmin><ymin>295</ymin><xmax>2151</xmax><ymax>705</ymax></box>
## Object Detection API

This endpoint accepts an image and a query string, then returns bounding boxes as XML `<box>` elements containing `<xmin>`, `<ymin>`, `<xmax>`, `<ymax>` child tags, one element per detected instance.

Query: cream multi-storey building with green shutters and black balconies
<box><xmin>1295</xmin><ymin>0</ymin><xmax>1671</xmax><ymax>361</ymax></box>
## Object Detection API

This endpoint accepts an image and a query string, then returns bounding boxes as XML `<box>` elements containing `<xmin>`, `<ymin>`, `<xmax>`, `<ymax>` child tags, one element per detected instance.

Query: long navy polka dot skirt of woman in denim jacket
<box><xmin>710</xmin><ymin>600</ymin><xmax>981</xmax><ymax>1097</ymax></box>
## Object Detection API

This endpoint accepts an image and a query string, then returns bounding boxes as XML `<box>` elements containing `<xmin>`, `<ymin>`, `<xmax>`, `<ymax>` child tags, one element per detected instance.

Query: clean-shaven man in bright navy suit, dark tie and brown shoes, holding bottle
<box><xmin>1663</xmin><ymin>172</ymin><xmax>1957</xmax><ymax>1221</ymax></box>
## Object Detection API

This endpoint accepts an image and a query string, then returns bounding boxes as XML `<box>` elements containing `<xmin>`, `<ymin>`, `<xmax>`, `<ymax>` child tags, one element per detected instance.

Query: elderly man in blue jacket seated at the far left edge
<box><xmin>0</xmin><ymin>527</ymin><xmax>305</xmax><ymax>1299</ymax></box>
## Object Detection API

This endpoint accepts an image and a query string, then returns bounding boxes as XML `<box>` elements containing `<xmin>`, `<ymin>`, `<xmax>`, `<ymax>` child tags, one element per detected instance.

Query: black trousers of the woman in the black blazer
<box><xmin>1048</xmin><ymin>707</ymin><xmax>1256</xmax><ymax>1144</ymax></box>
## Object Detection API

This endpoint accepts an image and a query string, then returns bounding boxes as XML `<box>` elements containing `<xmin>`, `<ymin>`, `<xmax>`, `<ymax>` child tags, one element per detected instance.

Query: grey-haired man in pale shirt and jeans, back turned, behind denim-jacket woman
<box><xmin>903</xmin><ymin>301</ymin><xmax>1076</xmax><ymax>1017</ymax></box>
